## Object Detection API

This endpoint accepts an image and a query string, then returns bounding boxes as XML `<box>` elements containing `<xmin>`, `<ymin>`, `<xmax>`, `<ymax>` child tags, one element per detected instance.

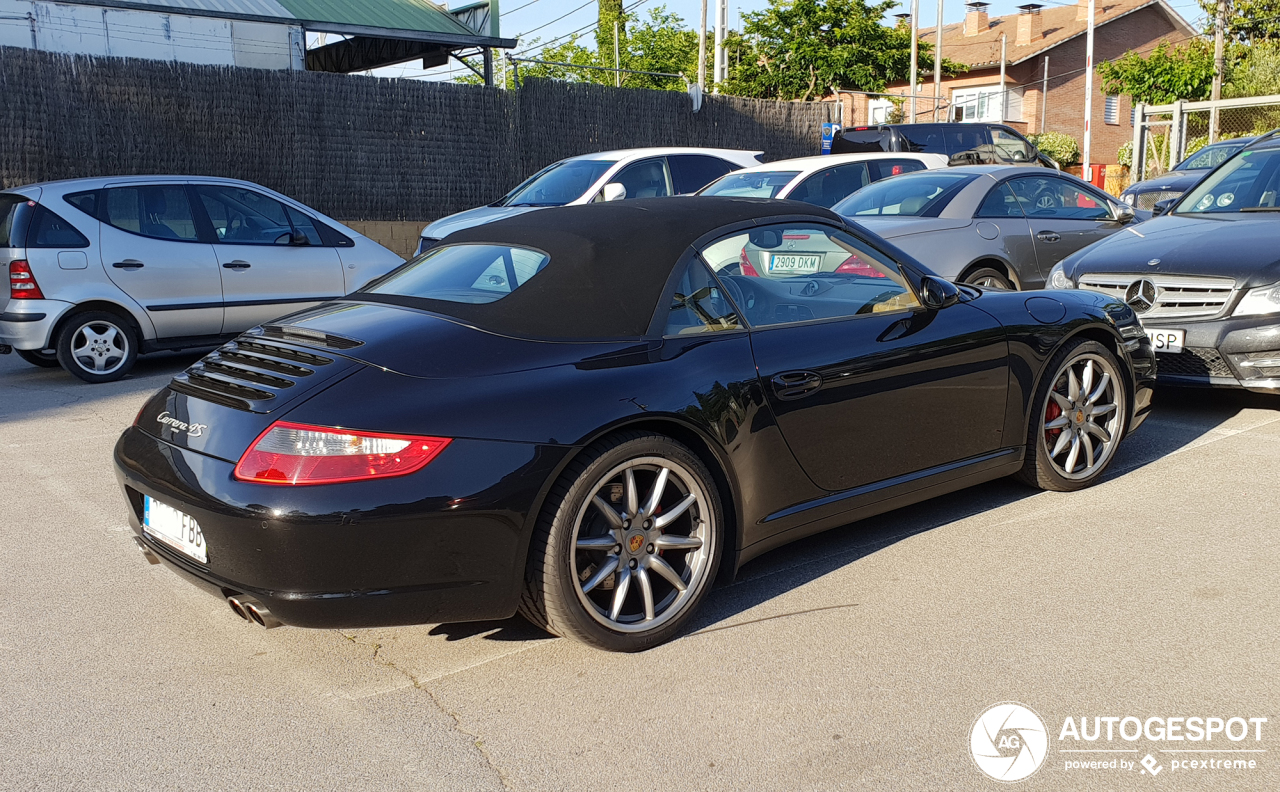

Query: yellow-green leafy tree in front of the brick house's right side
<box><xmin>1097</xmin><ymin>38</ymin><xmax>1213</xmax><ymax>105</ymax></box>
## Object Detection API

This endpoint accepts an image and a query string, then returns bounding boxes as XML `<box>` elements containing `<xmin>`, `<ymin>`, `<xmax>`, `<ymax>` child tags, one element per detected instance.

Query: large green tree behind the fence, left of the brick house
<box><xmin>721</xmin><ymin>0</ymin><xmax>965</xmax><ymax>100</ymax></box>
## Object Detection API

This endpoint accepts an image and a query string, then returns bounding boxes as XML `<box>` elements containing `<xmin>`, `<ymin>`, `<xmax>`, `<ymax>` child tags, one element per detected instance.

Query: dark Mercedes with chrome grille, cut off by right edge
<box><xmin>1050</xmin><ymin>132</ymin><xmax>1280</xmax><ymax>393</ymax></box>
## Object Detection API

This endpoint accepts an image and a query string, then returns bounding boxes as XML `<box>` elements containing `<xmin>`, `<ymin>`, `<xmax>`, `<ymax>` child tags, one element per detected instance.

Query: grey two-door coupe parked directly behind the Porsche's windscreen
<box><xmin>833</xmin><ymin>165</ymin><xmax>1151</xmax><ymax>289</ymax></box>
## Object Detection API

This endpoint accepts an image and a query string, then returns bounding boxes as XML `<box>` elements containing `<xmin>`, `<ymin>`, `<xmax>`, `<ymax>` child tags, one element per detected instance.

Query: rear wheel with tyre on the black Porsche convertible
<box><xmin>520</xmin><ymin>432</ymin><xmax>723</xmax><ymax>651</ymax></box>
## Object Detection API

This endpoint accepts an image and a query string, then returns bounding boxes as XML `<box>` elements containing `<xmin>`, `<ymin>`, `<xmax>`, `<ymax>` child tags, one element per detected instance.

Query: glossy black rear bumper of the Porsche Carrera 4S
<box><xmin>115</xmin><ymin>427</ymin><xmax>567</xmax><ymax>627</ymax></box>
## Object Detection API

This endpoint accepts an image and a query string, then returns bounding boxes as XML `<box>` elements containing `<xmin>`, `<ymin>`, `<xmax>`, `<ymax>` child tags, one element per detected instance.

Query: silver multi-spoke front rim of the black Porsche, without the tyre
<box><xmin>1041</xmin><ymin>353</ymin><xmax>1125</xmax><ymax>481</ymax></box>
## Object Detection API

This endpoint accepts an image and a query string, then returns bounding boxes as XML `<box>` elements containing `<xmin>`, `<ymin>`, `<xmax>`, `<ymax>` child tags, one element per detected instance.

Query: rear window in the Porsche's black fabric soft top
<box><xmin>364</xmin><ymin>244</ymin><xmax>550</xmax><ymax>305</ymax></box>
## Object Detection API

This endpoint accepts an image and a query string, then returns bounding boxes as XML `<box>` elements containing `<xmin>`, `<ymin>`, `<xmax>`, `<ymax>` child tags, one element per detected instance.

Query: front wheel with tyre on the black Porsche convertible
<box><xmin>1019</xmin><ymin>339</ymin><xmax>1129</xmax><ymax>493</ymax></box>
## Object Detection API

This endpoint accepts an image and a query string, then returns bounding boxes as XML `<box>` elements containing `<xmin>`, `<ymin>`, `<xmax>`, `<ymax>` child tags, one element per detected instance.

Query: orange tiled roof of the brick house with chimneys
<box><xmin>920</xmin><ymin>0</ymin><xmax>1196</xmax><ymax>67</ymax></box>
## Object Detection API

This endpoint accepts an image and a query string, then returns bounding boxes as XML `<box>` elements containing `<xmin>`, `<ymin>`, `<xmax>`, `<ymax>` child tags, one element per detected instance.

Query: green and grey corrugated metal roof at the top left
<box><xmin>61</xmin><ymin>0</ymin><xmax>476</xmax><ymax>38</ymax></box>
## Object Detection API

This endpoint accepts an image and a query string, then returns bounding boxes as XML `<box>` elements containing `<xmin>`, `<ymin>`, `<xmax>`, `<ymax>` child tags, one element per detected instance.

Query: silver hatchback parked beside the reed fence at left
<box><xmin>0</xmin><ymin>177</ymin><xmax>403</xmax><ymax>383</ymax></box>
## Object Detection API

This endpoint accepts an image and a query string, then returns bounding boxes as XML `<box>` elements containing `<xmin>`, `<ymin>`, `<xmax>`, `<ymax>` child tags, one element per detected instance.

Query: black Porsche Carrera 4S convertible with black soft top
<box><xmin>115</xmin><ymin>197</ymin><xmax>1155</xmax><ymax>651</ymax></box>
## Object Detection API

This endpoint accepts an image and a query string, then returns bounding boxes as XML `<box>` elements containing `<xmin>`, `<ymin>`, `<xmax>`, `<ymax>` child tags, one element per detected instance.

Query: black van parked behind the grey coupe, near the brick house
<box><xmin>831</xmin><ymin>122</ymin><xmax>1059</xmax><ymax>169</ymax></box>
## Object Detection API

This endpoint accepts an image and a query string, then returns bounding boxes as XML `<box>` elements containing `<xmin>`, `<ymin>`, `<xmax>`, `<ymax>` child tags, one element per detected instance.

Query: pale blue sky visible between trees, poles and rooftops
<box><xmin>374</xmin><ymin>0</ymin><xmax>1204</xmax><ymax>79</ymax></box>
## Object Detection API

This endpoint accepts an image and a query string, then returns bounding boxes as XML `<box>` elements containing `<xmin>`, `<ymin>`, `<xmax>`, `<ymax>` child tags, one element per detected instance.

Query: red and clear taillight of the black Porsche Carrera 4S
<box><xmin>236</xmin><ymin>421</ymin><xmax>449</xmax><ymax>485</ymax></box>
